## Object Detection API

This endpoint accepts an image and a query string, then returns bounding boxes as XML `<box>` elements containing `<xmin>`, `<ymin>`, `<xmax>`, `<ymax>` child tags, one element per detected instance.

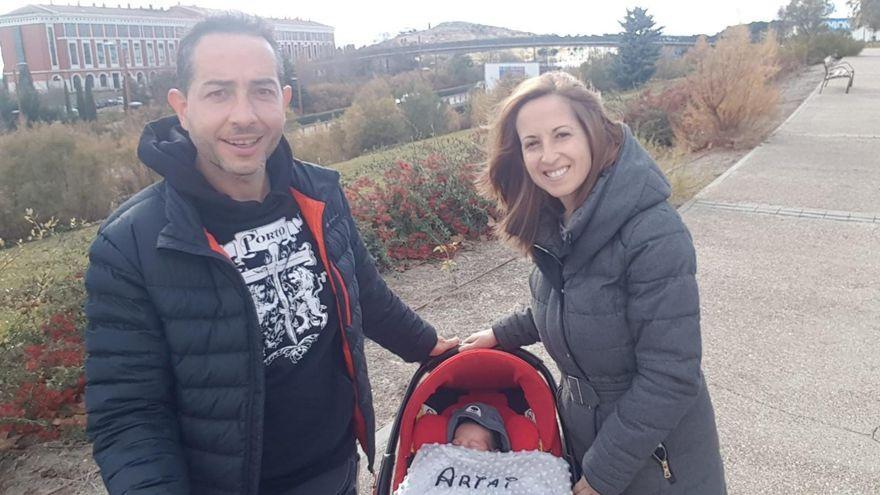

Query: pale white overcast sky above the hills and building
<box><xmin>0</xmin><ymin>0</ymin><xmax>849</xmax><ymax>70</ymax></box>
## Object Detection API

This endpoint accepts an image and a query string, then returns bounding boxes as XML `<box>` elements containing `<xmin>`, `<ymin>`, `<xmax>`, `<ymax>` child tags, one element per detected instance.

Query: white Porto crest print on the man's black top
<box><xmin>223</xmin><ymin>215</ymin><xmax>327</xmax><ymax>366</ymax></box>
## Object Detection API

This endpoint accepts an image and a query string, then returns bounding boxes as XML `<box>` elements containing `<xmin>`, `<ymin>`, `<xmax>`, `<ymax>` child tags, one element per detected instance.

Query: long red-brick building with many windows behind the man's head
<box><xmin>0</xmin><ymin>5</ymin><xmax>336</xmax><ymax>91</ymax></box>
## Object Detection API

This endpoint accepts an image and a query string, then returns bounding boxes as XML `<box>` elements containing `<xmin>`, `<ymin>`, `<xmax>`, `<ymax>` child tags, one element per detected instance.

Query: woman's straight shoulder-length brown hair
<box><xmin>479</xmin><ymin>72</ymin><xmax>623</xmax><ymax>254</ymax></box>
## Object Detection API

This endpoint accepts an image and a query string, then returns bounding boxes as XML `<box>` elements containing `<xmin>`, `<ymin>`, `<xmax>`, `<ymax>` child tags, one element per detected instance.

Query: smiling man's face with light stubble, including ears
<box><xmin>168</xmin><ymin>33</ymin><xmax>291</xmax><ymax>183</ymax></box>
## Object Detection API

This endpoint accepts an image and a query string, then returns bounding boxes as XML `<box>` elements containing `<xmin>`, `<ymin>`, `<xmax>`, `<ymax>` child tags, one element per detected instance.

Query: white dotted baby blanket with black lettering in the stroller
<box><xmin>394</xmin><ymin>444</ymin><xmax>571</xmax><ymax>495</ymax></box>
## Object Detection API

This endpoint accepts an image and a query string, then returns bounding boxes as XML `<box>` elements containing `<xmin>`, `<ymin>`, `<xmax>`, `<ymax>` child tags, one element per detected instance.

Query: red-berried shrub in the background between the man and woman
<box><xmin>346</xmin><ymin>155</ymin><xmax>491</xmax><ymax>270</ymax></box>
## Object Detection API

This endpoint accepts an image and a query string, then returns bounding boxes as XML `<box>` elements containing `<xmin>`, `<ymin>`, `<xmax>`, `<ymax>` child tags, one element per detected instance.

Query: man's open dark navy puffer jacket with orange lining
<box><xmin>86</xmin><ymin>121</ymin><xmax>437</xmax><ymax>495</ymax></box>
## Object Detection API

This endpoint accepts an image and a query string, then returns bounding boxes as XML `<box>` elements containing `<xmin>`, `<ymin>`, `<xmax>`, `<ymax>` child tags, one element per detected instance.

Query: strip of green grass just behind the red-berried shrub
<box><xmin>330</xmin><ymin>129</ymin><xmax>482</xmax><ymax>181</ymax></box>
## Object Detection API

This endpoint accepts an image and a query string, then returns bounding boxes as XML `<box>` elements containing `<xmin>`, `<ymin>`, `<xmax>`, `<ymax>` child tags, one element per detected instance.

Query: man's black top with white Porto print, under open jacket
<box><xmin>182</xmin><ymin>164</ymin><xmax>355</xmax><ymax>494</ymax></box>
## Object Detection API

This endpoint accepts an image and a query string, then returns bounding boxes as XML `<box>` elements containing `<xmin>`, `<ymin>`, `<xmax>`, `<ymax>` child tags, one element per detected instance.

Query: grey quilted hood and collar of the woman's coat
<box><xmin>538</xmin><ymin>124</ymin><xmax>671</xmax><ymax>266</ymax></box>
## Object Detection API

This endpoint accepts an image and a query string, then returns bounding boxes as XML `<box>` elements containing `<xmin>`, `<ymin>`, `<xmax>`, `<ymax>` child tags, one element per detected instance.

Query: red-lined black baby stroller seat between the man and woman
<box><xmin>373</xmin><ymin>349</ymin><xmax>580</xmax><ymax>495</ymax></box>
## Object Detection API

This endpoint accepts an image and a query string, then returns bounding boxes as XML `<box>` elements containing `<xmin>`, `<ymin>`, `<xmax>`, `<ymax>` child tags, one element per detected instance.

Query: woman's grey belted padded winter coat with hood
<box><xmin>493</xmin><ymin>129</ymin><xmax>726</xmax><ymax>495</ymax></box>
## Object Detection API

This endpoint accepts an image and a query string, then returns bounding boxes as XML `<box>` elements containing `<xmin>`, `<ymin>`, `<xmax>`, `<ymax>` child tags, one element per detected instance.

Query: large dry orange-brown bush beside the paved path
<box><xmin>673</xmin><ymin>26</ymin><xmax>779</xmax><ymax>151</ymax></box>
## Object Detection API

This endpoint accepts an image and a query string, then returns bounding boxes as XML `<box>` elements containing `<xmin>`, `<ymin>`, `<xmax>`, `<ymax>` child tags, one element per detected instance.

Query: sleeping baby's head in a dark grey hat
<box><xmin>447</xmin><ymin>402</ymin><xmax>510</xmax><ymax>452</ymax></box>
